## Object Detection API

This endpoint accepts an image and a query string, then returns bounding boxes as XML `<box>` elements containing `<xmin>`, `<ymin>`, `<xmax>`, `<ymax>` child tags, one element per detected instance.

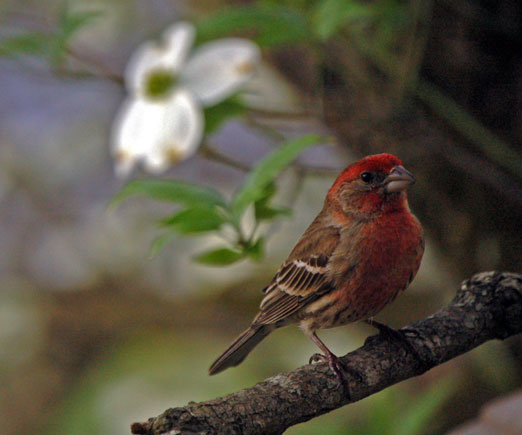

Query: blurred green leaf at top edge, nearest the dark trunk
<box><xmin>312</xmin><ymin>0</ymin><xmax>376</xmax><ymax>39</ymax></box>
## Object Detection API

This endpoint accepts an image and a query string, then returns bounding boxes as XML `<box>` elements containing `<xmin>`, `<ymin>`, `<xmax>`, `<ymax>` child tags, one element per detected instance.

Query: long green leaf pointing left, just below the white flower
<box><xmin>111</xmin><ymin>180</ymin><xmax>226</xmax><ymax>207</ymax></box>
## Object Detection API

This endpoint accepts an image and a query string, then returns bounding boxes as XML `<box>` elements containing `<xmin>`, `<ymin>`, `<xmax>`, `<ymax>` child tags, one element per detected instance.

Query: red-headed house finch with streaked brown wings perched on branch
<box><xmin>209</xmin><ymin>154</ymin><xmax>424</xmax><ymax>381</ymax></box>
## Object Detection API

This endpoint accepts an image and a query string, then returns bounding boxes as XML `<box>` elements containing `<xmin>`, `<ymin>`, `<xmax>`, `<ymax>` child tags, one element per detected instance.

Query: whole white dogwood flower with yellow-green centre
<box><xmin>111</xmin><ymin>22</ymin><xmax>260</xmax><ymax>176</ymax></box>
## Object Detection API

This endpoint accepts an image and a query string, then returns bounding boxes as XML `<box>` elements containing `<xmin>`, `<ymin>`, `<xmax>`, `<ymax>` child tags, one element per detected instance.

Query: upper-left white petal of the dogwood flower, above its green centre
<box><xmin>124</xmin><ymin>22</ymin><xmax>195</xmax><ymax>93</ymax></box>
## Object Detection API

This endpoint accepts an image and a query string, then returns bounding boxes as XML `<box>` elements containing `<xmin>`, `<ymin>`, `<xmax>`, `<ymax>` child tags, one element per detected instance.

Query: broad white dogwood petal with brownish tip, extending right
<box><xmin>180</xmin><ymin>38</ymin><xmax>261</xmax><ymax>106</ymax></box>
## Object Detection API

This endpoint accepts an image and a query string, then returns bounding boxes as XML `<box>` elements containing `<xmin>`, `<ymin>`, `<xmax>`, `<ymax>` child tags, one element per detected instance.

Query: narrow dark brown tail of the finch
<box><xmin>208</xmin><ymin>325</ymin><xmax>274</xmax><ymax>375</ymax></box>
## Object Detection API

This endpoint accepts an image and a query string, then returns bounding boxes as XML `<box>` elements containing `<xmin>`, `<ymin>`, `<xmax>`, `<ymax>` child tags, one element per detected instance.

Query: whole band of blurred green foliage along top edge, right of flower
<box><xmin>197</xmin><ymin>0</ymin><xmax>408</xmax><ymax>47</ymax></box>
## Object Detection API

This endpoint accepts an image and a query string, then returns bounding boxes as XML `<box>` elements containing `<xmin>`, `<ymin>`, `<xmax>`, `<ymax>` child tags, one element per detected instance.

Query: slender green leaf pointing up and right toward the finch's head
<box><xmin>232</xmin><ymin>135</ymin><xmax>324</xmax><ymax>216</ymax></box>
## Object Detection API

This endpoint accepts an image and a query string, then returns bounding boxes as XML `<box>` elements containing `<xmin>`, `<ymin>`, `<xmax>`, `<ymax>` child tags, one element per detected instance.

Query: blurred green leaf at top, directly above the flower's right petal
<box><xmin>196</xmin><ymin>4</ymin><xmax>309</xmax><ymax>47</ymax></box>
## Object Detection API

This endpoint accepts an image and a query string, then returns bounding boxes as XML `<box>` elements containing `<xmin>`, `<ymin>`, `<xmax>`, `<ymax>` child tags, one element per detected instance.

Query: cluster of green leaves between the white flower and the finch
<box><xmin>111</xmin><ymin>135</ymin><xmax>321</xmax><ymax>266</ymax></box>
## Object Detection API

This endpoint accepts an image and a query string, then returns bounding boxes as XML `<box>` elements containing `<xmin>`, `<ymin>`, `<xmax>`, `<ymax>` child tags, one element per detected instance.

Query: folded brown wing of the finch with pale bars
<box><xmin>254</xmin><ymin>227</ymin><xmax>339</xmax><ymax>324</ymax></box>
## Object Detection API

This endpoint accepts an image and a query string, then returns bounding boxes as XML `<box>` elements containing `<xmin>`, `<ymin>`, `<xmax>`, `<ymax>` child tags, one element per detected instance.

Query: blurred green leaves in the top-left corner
<box><xmin>0</xmin><ymin>5</ymin><xmax>102</xmax><ymax>67</ymax></box>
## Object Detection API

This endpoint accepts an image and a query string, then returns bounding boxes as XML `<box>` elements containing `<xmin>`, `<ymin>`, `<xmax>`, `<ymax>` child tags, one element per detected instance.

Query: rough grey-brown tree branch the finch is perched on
<box><xmin>131</xmin><ymin>272</ymin><xmax>522</xmax><ymax>434</ymax></box>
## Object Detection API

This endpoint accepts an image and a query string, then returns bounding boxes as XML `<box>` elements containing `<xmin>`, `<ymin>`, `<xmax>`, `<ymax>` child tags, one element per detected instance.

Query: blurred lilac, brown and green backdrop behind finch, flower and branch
<box><xmin>0</xmin><ymin>0</ymin><xmax>522</xmax><ymax>435</ymax></box>
